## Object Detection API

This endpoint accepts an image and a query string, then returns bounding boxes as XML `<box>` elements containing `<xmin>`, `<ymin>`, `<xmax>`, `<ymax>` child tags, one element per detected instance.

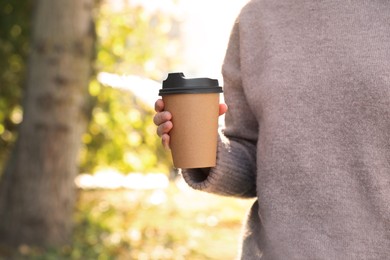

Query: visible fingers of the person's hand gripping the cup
<box><xmin>153</xmin><ymin>99</ymin><xmax>227</xmax><ymax>149</ymax></box>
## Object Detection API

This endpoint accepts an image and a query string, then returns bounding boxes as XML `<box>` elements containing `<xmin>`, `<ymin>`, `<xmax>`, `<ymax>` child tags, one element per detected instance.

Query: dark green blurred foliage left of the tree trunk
<box><xmin>0</xmin><ymin>0</ymin><xmax>34</xmax><ymax>169</ymax></box>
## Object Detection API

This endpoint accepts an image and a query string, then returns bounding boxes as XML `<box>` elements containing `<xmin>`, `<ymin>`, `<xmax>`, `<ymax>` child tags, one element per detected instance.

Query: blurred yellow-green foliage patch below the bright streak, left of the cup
<box><xmin>81</xmin><ymin>81</ymin><xmax>170</xmax><ymax>173</ymax></box>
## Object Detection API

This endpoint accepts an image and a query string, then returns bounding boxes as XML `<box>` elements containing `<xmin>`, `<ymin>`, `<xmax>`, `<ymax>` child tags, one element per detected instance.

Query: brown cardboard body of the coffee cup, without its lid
<box><xmin>162</xmin><ymin>93</ymin><xmax>219</xmax><ymax>168</ymax></box>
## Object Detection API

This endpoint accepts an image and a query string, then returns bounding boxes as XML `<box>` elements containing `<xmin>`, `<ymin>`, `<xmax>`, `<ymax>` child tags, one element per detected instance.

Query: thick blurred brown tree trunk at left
<box><xmin>0</xmin><ymin>0</ymin><xmax>95</xmax><ymax>246</ymax></box>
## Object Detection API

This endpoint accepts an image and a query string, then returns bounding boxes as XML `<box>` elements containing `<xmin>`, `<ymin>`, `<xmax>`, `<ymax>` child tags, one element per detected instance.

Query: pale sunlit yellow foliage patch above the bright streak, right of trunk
<box><xmin>96</xmin><ymin>0</ymin><xmax>180</xmax><ymax>80</ymax></box>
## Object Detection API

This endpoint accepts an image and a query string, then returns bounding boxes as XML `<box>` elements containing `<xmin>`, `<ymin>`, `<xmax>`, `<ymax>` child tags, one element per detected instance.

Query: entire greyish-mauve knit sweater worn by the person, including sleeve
<box><xmin>183</xmin><ymin>0</ymin><xmax>390</xmax><ymax>260</ymax></box>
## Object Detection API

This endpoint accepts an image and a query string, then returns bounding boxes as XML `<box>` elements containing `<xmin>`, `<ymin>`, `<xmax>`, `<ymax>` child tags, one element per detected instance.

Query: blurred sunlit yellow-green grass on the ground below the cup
<box><xmin>0</xmin><ymin>178</ymin><xmax>253</xmax><ymax>260</ymax></box>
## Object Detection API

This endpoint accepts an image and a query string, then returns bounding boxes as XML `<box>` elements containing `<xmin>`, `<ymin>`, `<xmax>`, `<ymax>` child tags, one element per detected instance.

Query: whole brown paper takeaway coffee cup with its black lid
<box><xmin>159</xmin><ymin>73</ymin><xmax>222</xmax><ymax>168</ymax></box>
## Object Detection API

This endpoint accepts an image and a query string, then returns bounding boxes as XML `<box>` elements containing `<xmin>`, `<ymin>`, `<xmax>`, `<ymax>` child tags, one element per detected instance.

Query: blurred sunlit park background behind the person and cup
<box><xmin>0</xmin><ymin>0</ymin><xmax>253</xmax><ymax>259</ymax></box>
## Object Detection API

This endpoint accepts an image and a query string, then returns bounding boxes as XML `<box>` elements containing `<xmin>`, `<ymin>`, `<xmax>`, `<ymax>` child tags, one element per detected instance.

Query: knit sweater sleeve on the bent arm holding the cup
<box><xmin>181</xmin><ymin>22</ymin><xmax>258</xmax><ymax>198</ymax></box>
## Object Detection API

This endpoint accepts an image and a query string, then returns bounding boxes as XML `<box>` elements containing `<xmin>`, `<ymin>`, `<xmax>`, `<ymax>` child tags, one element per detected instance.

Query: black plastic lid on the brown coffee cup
<box><xmin>159</xmin><ymin>72</ymin><xmax>222</xmax><ymax>96</ymax></box>
